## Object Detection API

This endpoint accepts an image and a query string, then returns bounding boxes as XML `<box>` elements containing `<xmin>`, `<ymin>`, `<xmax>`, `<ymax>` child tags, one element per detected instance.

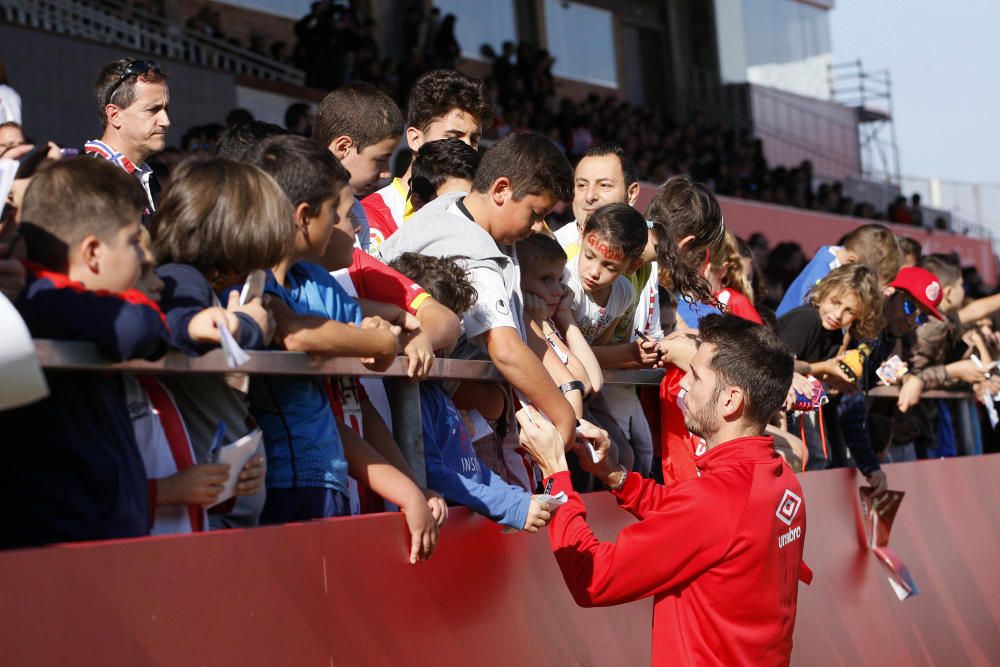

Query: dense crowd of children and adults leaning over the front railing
<box><xmin>0</xmin><ymin>54</ymin><xmax>1000</xmax><ymax>562</ymax></box>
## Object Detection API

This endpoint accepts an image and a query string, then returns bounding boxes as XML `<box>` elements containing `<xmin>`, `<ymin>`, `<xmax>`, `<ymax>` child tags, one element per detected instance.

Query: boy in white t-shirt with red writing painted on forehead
<box><xmin>567</xmin><ymin>204</ymin><xmax>648</xmax><ymax>345</ymax></box>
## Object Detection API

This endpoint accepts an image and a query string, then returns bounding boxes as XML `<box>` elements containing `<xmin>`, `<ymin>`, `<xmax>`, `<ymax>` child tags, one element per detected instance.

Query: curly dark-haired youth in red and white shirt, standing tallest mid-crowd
<box><xmin>363</xmin><ymin>69</ymin><xmax>492</xmax><ymax>252</ymax></box>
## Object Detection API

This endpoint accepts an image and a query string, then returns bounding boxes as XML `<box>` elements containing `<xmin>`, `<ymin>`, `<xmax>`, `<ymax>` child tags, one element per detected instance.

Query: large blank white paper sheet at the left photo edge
<box><xmin>0</xmin><ymin>294</ymin><xmax>49</xmax><ymax>410</ymax></box>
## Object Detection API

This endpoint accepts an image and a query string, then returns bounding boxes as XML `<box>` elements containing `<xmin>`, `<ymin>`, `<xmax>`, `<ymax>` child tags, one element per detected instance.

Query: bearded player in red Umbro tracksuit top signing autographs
<box><xmin>518</xmin><ymin>315</ymin><xmax>806</xmax><ymax>665</ymax></box>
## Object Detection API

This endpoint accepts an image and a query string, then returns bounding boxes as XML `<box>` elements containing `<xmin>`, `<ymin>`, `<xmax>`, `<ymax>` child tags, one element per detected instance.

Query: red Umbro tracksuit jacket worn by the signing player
<box><xmin>549</xmin><ymin>437</ymin><xmax>806</xmax><ymax>665</ymax></box>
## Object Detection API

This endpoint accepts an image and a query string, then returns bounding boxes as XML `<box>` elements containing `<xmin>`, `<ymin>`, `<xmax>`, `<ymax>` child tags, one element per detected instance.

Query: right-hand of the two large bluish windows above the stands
<box><xmin>545</xmin><ymin>0</ymin><xmax>618</xmax><ymax>88</ymax></box>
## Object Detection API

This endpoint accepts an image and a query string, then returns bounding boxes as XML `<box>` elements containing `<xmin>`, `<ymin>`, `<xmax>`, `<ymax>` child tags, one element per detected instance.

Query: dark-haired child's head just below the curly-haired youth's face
<box><xmin>408</xmin><ymin>139</ymin><xmax>479</xmax><ymax>211</ymax></box>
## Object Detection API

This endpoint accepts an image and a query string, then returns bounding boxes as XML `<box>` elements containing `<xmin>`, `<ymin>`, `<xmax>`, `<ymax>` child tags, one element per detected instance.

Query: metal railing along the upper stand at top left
<box><xmin>0</xmin><ymin>0</ymin><xmax>305</xmax><ymax>85</ymax></box>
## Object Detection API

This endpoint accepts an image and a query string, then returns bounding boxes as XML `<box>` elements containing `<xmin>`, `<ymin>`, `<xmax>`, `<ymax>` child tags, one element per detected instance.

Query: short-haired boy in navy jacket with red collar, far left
<box><xmin>0</xmin><ymin>158</ymin><xmax>168</xmax><ymax>548</ymax></box>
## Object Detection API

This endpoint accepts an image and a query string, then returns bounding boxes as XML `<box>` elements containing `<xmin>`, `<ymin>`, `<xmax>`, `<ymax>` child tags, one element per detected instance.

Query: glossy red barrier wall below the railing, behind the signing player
<box><xmin>0</xmin><ymin>456</ymin><xmax>1000</xmax><ymax>667</ymax></box>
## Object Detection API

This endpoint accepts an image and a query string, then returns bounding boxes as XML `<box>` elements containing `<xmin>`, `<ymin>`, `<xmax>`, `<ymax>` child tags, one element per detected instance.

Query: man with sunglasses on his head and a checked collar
<box><xmin>84</xmin><ymin>58</ymin><xmax>170</xmax><ymax>216</ymax></box>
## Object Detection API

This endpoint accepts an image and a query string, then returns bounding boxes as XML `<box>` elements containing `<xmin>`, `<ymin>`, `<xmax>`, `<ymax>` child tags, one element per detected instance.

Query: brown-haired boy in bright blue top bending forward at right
<box><xmin>777</xmin><ymin>225</ymin><xmax>900</xmax><ymax>317</ymax></box>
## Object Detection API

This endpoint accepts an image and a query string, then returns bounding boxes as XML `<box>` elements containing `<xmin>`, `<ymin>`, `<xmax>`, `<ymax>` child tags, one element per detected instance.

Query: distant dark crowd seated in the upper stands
<box><xmin>280</xmin><ymin>2</ymin><xmax>947</xmax><ymax>229</ymax></box>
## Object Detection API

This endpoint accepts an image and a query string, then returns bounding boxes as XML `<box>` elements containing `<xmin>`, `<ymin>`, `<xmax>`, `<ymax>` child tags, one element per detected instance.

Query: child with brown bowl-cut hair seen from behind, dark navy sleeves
<box><xmin>152</xmin><ymin>159</ymin><xmax>286</xmax><ymax>528</ymax></box>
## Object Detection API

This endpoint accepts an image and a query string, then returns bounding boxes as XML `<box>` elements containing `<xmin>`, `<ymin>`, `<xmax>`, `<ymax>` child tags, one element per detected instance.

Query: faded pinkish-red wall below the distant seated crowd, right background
<box><xmin>635</xmin><ymin>183</ymin><xmax>997</xmax><ymax>285</ymax></box>
